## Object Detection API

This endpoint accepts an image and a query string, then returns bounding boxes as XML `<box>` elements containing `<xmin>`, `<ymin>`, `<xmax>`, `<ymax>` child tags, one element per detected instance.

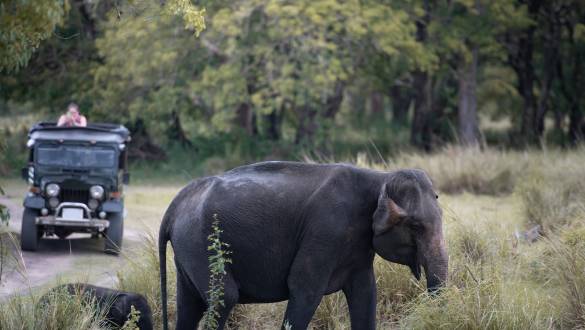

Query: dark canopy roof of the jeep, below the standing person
<box><xmin>28</xmin><ymin>122</ymin><xmax>130</xmax><ymax>143</ymax></box>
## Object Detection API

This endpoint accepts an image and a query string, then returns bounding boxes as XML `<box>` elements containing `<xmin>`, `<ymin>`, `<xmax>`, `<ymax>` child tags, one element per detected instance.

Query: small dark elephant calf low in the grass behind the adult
<box><xmin>42</xmin><ymin>283</ymin><xmax>153</xmax><ymax>330</ymax></box>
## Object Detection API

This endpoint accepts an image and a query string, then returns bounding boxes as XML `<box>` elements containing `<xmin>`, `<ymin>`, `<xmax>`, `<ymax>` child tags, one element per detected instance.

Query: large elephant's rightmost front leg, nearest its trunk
<box><xmin>343</xmin><ymin>268</ymin><xmax>376</xmax><ymax>330</ymax></box>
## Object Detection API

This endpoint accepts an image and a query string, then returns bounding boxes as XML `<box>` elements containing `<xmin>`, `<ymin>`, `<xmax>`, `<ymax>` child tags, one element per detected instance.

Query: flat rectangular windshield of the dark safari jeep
<box><xmin>36</xmin><ymin>145</ymin><xmax>116</xmax><ymax>168</ymax></box>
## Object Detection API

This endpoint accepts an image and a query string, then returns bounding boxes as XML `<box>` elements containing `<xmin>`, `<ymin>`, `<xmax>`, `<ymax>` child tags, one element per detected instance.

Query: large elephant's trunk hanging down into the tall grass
<box><xmin>423</xmin><ymin>235</ymin><xmax>449</xmax><ymax>293</ymax></box>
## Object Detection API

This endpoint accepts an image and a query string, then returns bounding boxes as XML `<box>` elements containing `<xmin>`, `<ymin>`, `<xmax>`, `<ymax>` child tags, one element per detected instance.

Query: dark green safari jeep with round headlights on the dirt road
<box><xmin>21</xmin><ymin>123</ymin><xmax>130</xmax><ymax>254</ymax></box>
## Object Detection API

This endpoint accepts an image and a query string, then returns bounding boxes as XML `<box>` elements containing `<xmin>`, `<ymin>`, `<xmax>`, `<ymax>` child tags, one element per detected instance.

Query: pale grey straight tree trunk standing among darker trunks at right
<box><xmin>457</xmin><ymin>46</ymin><xmax>479</xmax><ymax>146</ymax></box>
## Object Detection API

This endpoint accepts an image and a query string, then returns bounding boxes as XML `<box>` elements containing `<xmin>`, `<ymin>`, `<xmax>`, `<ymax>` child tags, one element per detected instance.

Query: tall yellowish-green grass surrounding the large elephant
<box><xmin>0</xmin><ymin>147</ymin><xmax>585</xmax><ymax>329</ymax></box>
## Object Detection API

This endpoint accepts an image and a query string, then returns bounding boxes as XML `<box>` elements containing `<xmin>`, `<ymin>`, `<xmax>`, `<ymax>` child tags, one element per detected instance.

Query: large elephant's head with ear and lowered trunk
<box><xmin>372</xmin><ymin>170</ymin><xmax>448</xmax><ymax>292</ymax></box>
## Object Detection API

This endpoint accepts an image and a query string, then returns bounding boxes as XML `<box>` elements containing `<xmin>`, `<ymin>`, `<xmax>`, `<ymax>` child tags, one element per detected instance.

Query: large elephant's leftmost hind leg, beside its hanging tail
<box><xmin>177</xmin><ymin>269</ymin><xmax>207</xmax><ymax>330</ymax></box>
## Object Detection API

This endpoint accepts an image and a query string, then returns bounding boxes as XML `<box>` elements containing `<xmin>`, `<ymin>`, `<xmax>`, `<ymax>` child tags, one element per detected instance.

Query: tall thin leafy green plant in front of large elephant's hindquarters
<box><xmin>203</xmin><ymin>214</ymin><xmax>232</xmax><ymax>329</ymax></box>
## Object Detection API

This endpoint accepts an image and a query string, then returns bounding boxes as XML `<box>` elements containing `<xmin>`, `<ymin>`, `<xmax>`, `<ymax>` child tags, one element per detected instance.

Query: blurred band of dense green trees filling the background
<box><xmin>0</xmin><ymin>0</ymin><xmax>585</xmax><ymax>170</ymax></box>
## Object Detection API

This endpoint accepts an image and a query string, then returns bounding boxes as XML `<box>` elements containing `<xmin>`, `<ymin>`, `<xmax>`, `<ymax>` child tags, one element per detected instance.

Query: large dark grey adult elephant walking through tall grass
<box><xmin>159</xmin><ymin>161</ymin><xmax>448</xmax><ymax>330</ymax></box>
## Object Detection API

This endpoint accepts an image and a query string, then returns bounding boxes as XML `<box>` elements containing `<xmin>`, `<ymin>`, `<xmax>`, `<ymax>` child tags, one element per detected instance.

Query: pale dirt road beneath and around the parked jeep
<box><xmin>0</xmin><ymin>183</ymin><xmax>178</xmax><ymax>299</ymax></box>
